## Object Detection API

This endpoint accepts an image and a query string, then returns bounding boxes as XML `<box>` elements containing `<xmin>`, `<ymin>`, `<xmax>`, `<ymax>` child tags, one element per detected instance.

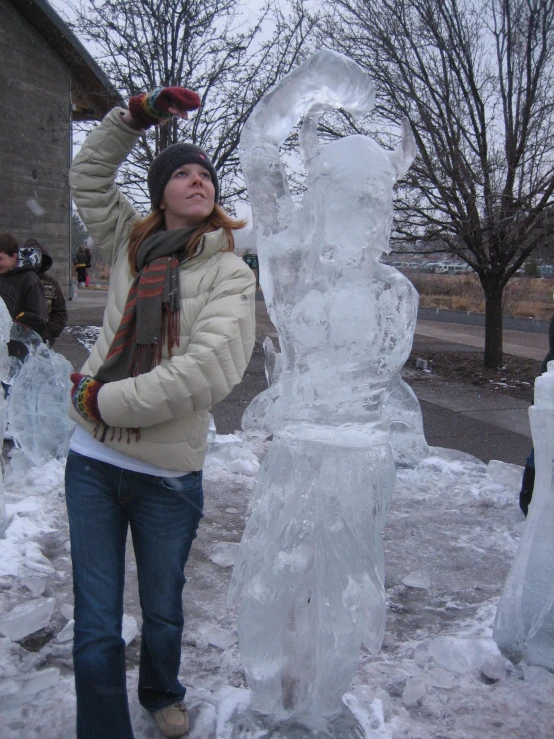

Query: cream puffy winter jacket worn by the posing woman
<box><xmin>70</xmin><ymin>108</ymin><xmax>255</xmax><ymax>471</ymax></box>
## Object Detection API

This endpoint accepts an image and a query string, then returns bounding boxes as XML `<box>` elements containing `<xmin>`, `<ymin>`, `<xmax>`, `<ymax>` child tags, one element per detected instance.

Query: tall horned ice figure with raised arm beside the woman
<box><xmin>229</xmin><ymin>51</ymin><xmax>425</xmax><ymax>736</ymax></box>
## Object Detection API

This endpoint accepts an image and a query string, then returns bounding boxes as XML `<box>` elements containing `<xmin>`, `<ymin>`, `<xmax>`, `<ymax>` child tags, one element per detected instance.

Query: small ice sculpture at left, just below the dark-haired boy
<box><xmin>8</xmin><ymin>324</ymin><xmax>75</xmax><ymax>465</ymax></box>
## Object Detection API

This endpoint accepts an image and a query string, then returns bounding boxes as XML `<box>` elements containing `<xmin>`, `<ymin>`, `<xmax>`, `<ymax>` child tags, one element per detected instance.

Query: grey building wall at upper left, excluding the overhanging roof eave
<box><xmin>0</xmin><ymin>0</ymin><xmax>71</xmax><ymax>296</ymax></box>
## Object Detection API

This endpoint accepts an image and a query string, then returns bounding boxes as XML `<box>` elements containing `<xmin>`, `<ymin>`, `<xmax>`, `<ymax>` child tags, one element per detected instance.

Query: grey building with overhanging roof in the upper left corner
<box><xmin>0</xmin><ymin>0</ymin><xmax>121</xmax><ymax>294</ymax></box>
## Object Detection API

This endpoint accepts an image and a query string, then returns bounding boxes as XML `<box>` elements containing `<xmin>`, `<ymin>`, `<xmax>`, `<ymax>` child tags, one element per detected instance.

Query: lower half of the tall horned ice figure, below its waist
<box><xmin>226</xmin><ymin>424</ymin><xmax>396</xmax><ymax>722</ymax></box>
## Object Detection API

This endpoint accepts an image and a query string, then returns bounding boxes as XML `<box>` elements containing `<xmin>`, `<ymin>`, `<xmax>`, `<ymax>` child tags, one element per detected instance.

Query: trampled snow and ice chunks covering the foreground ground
<box><xmin>0</xmin><ymin>436</ymin><xmax>554</xmax><ymax>739</ymax></box>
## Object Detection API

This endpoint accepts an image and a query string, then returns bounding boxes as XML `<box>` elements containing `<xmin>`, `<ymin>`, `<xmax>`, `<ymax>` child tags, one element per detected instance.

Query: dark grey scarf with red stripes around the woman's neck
<box><xmin>94</xmin><ymin>228</ymin><xmax>195</xmax><ymax>382</ymax></box>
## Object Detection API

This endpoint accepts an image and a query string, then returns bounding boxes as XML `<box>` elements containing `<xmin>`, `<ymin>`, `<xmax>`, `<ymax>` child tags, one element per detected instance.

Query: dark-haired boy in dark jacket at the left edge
<box><xmin>0</xmin><ymin>233</ymin><xmax>46</xmax><ymax>359</ymax></box>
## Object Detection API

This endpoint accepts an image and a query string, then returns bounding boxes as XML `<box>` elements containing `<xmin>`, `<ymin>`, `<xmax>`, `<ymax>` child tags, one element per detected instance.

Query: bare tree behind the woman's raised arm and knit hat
<box><xmin>64</xmin><ymin>0</ymin><xmax>312</xmax><ymax>207</ymax></box>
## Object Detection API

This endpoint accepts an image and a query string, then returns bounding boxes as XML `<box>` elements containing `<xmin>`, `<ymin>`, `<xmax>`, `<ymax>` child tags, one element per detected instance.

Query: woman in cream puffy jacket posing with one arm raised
<box><xmin>66</xmin><ymin>88</ymin><xmax>255</xmax><ymax>739</ymax></box>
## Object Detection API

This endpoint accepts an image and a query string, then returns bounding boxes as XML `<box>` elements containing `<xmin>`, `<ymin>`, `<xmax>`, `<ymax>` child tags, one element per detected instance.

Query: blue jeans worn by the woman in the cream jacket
<box><xmin>65</xmin><ymin>451</ymin><xmax>204</xmax><ymax>739</ymax></box>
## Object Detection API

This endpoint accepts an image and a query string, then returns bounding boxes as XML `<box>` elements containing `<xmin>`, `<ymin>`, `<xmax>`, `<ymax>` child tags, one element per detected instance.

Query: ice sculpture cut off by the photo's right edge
<box><xmin>493</xmin><ymin>362</ymin><xmax>554</xmax><ymax>671</ymax></box>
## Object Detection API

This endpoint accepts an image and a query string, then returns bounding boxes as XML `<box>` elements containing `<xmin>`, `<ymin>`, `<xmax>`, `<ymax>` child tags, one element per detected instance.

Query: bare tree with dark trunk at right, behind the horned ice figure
<box><xmin>314</xmin><ymin>0</ymin><xmax>554</xmax><ymax>367</ymax></box>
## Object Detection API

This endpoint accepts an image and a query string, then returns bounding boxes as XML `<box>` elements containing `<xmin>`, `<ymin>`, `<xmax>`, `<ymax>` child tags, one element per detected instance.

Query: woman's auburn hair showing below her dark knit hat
<box><xmin>128</xmin><ymin>203</ymin><xmax>246</xmax><ymax>277</ymax></box>
